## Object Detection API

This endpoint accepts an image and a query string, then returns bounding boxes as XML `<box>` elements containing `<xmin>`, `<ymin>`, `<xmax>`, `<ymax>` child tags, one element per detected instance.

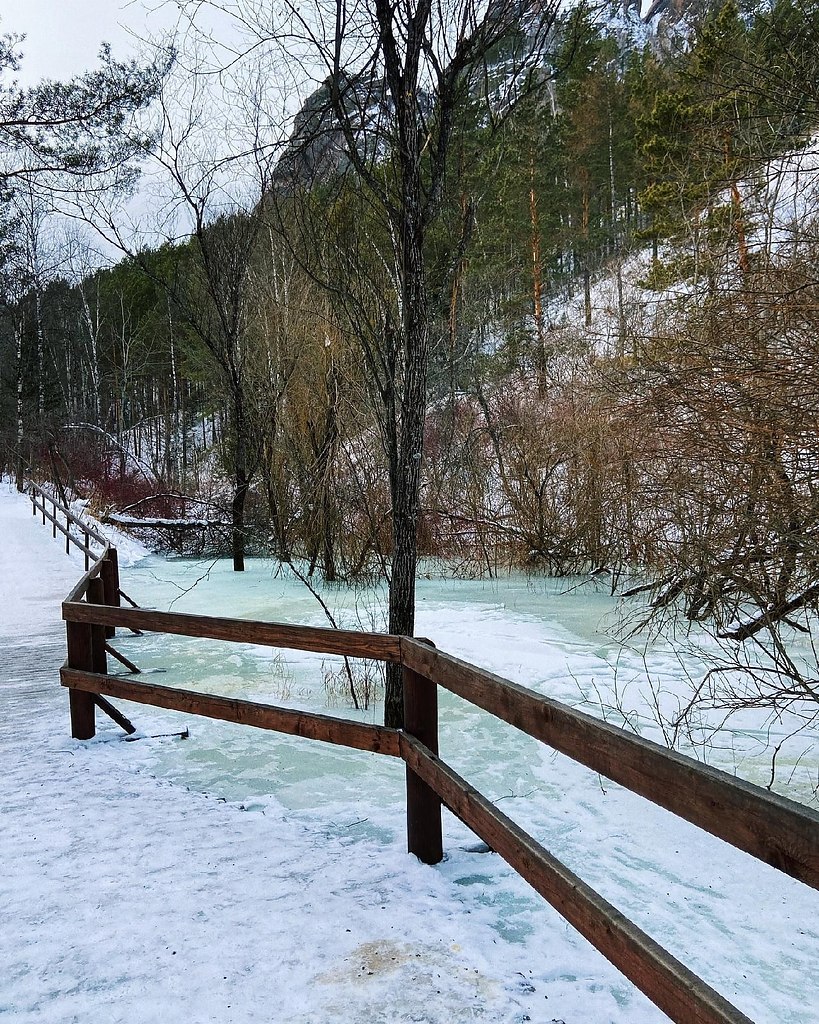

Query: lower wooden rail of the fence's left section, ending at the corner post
<box><xmin>59</xmin><ymin>666</ymin><xmax>400</xmax><ymax>757</ymax></box>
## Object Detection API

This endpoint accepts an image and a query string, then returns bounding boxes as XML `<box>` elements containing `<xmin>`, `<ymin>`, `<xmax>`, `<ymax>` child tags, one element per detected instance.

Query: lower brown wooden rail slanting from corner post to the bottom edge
<box><xmin>400</xmin><ymin>734</ymin><xmax>751</xmax><ymax>1024</ymax></box>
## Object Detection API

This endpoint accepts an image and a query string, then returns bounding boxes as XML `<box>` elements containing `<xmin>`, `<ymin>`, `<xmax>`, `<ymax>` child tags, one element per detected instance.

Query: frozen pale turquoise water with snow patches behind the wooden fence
<box><xmin>102</xmin><ymin>558</ymin><xmax>819</xmax><ymax>1024</ymax></box>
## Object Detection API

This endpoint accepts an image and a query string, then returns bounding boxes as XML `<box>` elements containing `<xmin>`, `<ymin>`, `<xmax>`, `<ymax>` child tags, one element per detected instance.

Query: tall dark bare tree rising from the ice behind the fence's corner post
<box><xmin>177</xmin><ymin>0</ymin><xmax>557</xmax><ymax>725</ymax></box>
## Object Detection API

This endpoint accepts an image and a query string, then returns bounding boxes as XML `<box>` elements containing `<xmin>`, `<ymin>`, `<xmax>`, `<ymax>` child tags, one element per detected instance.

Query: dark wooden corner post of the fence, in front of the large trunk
<box><xmin>402</xmin><ymin>667</ymin><xmax>443</xmax><ymax>864</ymax></box>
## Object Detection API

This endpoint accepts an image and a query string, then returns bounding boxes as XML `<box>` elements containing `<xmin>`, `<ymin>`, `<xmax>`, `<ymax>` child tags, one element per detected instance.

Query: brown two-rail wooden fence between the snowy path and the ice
<box><xmin>32</xmin><ymin>488</ymin><xmax>819</xmax><ymax>1024</ymax></box>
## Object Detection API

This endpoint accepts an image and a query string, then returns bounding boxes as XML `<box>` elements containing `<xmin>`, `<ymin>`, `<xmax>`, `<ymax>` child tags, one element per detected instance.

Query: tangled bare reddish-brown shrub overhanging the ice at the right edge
<box><xmin>597</xmin><ymin>243</ymin><xmax>819</xmax><ymax>765</ymax></box>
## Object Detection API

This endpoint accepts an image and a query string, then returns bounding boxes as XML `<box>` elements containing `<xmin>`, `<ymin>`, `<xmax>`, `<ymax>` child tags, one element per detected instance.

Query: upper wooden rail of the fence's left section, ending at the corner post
<box><xmin>62</xmin><ymin>601</ymin><xmax>401</xmax><ymax>662</ymax></box>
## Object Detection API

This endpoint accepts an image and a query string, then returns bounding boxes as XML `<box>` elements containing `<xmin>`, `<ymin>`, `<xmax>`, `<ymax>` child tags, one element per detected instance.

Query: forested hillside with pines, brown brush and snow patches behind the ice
<box><xmin>0</xmin><ymin>0</ymin><xmax>819</xmax><ymax>720</ymax></box>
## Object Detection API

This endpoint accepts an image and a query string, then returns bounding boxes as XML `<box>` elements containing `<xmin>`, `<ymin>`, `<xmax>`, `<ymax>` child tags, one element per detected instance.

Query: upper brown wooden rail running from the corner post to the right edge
<box><xmin>401</xmin><ymin>638</ymin><xmax>819</xmax><ymax>889</ymax></box>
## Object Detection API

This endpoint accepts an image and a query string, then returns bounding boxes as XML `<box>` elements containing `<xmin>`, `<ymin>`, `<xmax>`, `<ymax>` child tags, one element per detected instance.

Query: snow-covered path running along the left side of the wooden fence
<box><xmin>0</xmin><ymin>483</ymin><xmax>663</xmax><ymax>1024</ymax></box>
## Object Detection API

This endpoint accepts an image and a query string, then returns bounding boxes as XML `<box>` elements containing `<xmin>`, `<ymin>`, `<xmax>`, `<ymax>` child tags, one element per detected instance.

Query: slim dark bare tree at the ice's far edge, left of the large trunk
<box><xmin>84</xmin><ymin>49</ymin><xmax>288</xmax><ymax>571</ymax></box>
